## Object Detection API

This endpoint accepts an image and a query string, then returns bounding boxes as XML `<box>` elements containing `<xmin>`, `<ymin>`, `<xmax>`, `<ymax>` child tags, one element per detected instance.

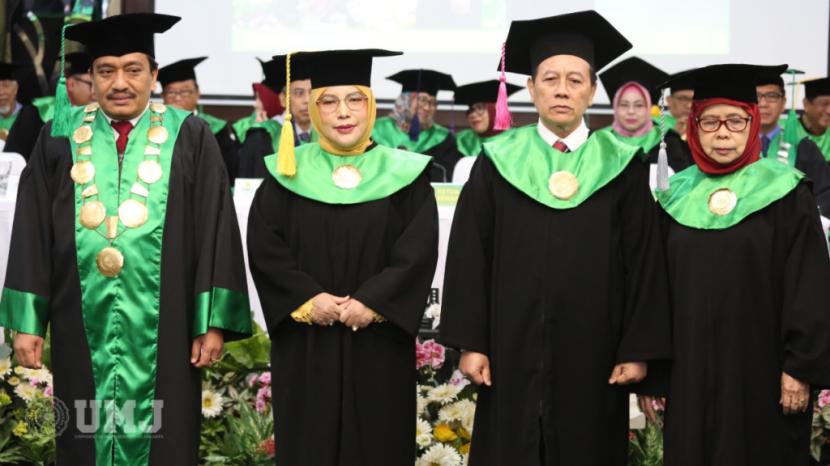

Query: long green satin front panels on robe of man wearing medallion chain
<box><xmin>69</xmin><ymin>106</ymin><xmax>191</xmax><ymax>466</ymax></box>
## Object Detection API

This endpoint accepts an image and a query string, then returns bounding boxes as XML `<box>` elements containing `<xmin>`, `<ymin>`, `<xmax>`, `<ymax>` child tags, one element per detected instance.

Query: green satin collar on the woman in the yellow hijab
<box><xmin>265</xmin><ymin>144</ymin><xmax>430</xmax><ymax>204</ymax></box>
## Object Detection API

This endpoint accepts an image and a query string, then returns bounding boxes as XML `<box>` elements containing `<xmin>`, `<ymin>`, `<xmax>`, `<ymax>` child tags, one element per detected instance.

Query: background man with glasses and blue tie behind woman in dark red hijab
<box><xmin>756</xmin><ymin>71</ymin><xmax>830</xmax><ymax>217</ymax></box>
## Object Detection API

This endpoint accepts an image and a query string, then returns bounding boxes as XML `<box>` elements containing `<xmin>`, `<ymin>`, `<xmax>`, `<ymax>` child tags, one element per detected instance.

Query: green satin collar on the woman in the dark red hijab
<box><xmin>657</xmin><ymin>159</ymin><xmax>804</xmax><ymax>230</ymax></box>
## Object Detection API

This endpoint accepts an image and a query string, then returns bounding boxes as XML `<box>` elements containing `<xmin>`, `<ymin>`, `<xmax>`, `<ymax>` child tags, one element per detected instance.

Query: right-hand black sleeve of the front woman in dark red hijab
<box><xmin>781</xmin><ymin>183</ymin><xmax>830</xmax><ymax>388</ymax></box>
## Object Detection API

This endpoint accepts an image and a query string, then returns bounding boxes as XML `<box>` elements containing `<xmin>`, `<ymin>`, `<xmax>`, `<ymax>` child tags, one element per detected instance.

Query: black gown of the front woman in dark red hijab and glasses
<box><xmin>663</xmin><ymin>182</ymin><xmax>830</xmax><ymax>466</ymax></box>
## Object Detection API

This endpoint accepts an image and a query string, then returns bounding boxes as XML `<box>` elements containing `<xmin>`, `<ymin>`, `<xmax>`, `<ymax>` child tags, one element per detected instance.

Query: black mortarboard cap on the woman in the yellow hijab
<box><xmin>300</xmin><ymin>49</ymin><xmax>402</xmax><ymax>89</ymax></box>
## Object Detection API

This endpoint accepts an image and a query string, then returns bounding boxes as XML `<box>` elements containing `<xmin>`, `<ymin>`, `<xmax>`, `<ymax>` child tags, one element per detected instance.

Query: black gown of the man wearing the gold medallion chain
<box><xmin>5</xmin><ymin>117</ymin><xmax>247</xmax><ymax>466</ymax></box>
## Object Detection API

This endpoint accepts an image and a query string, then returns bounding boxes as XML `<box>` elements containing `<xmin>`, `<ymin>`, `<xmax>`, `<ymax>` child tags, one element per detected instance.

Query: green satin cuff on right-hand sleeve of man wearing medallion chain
<box><xmin>193</xmin><ymin>288</ymin><xmax>253</xmax><ymax>338</ymax></box>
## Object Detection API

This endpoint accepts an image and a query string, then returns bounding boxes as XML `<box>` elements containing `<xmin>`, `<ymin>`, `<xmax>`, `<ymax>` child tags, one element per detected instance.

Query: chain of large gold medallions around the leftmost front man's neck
<box><xmin>70</xmin><ymin>103</ymin><xmax>170</xmax><ymax>278</ymax></box>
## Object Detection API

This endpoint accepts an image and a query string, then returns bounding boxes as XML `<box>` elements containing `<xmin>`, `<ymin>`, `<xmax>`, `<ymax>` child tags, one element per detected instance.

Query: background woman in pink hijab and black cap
<box><xmin>599</xmin><ymin>57</ymin><xmax>692</xmax><ymax>172</ymax></box>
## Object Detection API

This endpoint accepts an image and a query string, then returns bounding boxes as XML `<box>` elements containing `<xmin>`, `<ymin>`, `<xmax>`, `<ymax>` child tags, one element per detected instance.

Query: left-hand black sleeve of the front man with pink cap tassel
<box><xmin>439</xmin><ymin>157</ymin><xmax>495</xmax><ymax>354</ymax></box>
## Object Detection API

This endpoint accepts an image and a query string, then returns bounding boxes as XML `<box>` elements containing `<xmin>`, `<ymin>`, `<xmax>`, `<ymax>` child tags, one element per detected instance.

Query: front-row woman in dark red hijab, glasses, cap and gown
<box><xmin>657</xmin><ymin>65</ymin><xmax>830</xmax><ymax>466</ymax></box>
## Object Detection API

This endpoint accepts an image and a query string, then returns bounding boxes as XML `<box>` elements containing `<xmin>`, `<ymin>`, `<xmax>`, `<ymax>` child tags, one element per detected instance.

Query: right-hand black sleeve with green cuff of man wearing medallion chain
<box><xmin>187</xmin><ymin>117</ymin><xmax>251</xmax><ymax>341</ymax></box>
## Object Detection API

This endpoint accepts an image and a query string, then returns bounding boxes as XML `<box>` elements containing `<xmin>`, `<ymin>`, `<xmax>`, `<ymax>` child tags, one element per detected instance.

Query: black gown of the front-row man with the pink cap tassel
<box><xmin>439</xmin><ymin>156</ymin><xmax>671</xmax><ymax>466</ymax></box>
